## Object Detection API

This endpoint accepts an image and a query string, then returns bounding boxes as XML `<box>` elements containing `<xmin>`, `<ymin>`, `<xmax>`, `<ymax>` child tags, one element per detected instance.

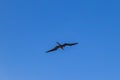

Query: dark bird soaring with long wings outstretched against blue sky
<box><xmin>47</xmin><ymin>42</ymin><xmax>78</xmax><ymax>53</ymax></box>
